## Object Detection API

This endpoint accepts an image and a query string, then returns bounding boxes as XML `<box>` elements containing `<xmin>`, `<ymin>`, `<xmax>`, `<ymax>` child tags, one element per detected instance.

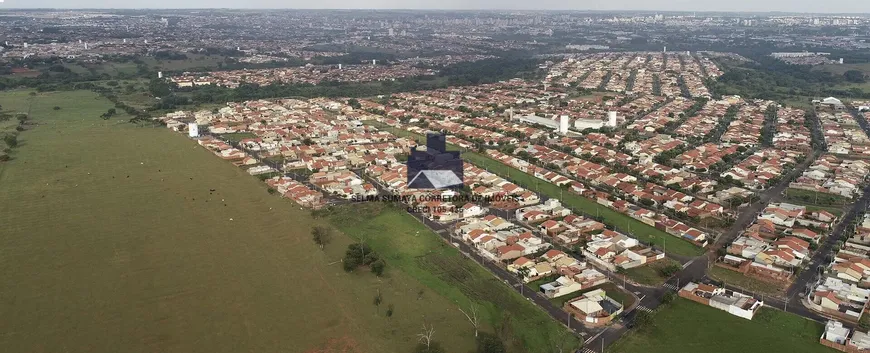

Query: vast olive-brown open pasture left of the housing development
<box><xmin>0</xmin><ymin>91</ymin><xmax>484</xmax><ymax>353</ymax></box>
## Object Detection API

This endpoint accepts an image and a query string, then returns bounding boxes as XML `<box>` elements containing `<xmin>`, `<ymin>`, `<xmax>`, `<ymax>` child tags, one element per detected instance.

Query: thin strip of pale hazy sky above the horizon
<box><xmin>0</xmin><ymin>0</ymin><xmax>870</xmax><ymax>13</ymax></box>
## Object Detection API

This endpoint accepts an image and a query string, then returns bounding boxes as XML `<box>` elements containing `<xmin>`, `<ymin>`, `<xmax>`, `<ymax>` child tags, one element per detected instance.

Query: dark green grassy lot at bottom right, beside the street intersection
<box><xmin>607</xmin><ymin>298</ymin><xmax>837</xmax><ymax>353</ymax></box>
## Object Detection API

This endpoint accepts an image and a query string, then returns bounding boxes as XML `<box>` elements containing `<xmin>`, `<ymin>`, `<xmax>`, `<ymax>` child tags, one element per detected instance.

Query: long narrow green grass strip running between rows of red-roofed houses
<box><xmin>370</xmin><ymin>122</ymin><xmax>704</xmax><ymax>256</ymax></box>
